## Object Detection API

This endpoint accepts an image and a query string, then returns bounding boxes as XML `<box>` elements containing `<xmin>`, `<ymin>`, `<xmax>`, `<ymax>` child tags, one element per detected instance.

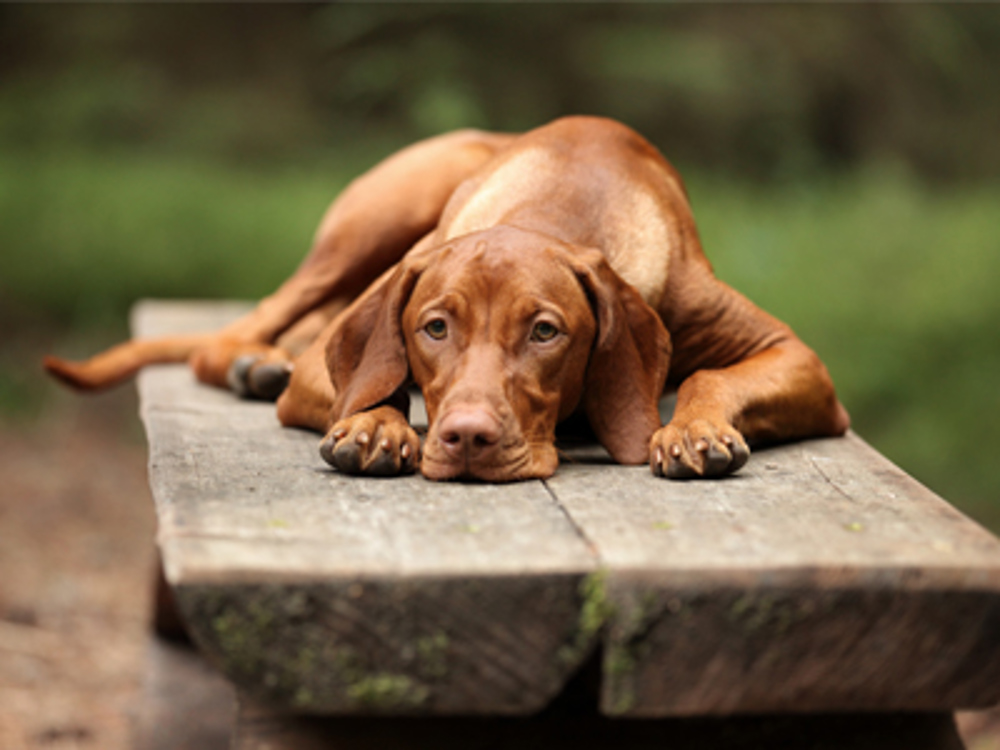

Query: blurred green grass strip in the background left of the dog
<box><xmin>0</xmin><ymin>152</ymin><xmax>347</xmax><ymax>324</ymax></box>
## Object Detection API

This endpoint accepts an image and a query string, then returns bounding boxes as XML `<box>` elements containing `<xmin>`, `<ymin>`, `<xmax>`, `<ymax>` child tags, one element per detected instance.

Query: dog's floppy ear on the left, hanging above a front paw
<box><xmin>326</xmin><ymin>259</ymin><xmax>427</xmax><ymax>422</ymax></box>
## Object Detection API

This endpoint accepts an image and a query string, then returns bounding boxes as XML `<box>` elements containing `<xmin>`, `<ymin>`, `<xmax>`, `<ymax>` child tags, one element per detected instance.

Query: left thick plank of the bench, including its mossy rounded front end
<box><xmin>136</xmin><ymin>305</ymin><xmax>596</xmax><ymax>713</ymax></box>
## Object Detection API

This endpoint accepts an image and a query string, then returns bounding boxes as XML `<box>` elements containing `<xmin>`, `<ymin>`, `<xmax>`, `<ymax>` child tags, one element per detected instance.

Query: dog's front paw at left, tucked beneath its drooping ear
<box><xmin>319</xmin><ymin>406</ymin><xmax>420</xmax><ymax>477</ymax></box>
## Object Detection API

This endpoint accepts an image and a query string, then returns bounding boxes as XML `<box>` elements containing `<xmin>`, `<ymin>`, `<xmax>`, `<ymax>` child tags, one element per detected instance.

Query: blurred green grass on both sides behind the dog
<box><xmin>0</xmin><ymin>150</ymin><xmax>1000</xmax><ymax>530</ymax></box>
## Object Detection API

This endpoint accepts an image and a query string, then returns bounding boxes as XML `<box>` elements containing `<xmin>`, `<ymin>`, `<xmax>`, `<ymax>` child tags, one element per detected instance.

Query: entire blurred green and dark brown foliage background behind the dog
<box><xmin>0</xmin><ymin>4</ymin><xmax>1000</xmax><ymax>529</ymax></box>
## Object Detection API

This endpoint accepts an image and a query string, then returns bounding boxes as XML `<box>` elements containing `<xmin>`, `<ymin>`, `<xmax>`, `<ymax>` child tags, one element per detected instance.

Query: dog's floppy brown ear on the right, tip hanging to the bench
<box><xmin>572</xmin><ymin>250</ymin><xmax>671</xmax><ymax>464</ymax></box>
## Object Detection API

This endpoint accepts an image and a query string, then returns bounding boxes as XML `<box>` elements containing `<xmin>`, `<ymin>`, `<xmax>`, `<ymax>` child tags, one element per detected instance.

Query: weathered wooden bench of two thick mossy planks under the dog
<box><xmin>133</xmin><ymin>302</ymin><xmax>1000</xmax><ymax>748</ymax></box>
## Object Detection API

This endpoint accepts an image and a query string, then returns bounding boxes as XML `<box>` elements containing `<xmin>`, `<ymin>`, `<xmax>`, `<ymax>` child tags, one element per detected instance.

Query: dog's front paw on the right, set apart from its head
<box><xmin>649</xmin><ymin>419</ymin><xmax>750</xmax><ymax>479</ymax></box>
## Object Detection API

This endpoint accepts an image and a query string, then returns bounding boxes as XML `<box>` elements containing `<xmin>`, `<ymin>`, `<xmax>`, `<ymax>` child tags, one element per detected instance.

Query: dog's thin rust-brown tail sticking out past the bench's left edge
<box><xmin>42</xmin><ymin>334</ymin><xmax>213</xmax><ymax>391</ymax></box>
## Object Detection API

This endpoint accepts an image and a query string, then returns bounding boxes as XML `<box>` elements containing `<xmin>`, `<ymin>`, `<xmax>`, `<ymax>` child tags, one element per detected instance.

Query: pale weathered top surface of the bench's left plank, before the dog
<box><xmin>142</xmin><ymin>378</ymin><xmax>593</xmax><ymax>583</ymax></box>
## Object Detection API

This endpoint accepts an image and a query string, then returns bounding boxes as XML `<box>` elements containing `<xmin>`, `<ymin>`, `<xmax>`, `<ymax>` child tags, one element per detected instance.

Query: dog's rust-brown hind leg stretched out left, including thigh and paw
<box><xmin>192</xmin><ymin>131</ymin><xmax>513</xmax><ymax>397</ymax></box>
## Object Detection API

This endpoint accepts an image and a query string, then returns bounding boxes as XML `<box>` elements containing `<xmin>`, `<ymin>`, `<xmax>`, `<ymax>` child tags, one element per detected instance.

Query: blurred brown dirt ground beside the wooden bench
<box><xmin>0</xmin><ymin>388</ymin><xmax>1000</xmax><ymax>750</ymax></box>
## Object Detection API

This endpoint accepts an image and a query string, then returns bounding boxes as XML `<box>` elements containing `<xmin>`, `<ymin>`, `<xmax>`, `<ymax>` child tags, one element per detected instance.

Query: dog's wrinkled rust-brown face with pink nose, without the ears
<box><xmin>402</xmin><ymin>238</ymin><xmax>597</xmax><ymax>481</ymax></box>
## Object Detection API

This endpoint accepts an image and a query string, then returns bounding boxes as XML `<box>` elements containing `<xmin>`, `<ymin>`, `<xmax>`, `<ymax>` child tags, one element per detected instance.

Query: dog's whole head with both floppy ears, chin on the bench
<box><xmin>327</xmin><ymin>227</ymin><xmax>670</xmax><ymax>481</ymax></box>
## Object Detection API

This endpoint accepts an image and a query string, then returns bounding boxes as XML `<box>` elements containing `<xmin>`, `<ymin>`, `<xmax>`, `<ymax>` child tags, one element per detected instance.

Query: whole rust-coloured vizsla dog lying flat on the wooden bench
<box><xmin>46</xmin><ymin>117</ymin><xmax>848</xmax><ymax>482</ymax></box>
